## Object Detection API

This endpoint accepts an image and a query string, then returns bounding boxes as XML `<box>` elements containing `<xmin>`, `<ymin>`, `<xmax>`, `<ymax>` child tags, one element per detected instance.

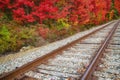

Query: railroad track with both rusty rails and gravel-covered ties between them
<box><xmin>0</xmin><ymin>22</ymin><xmax>119</xmax><ymax>80</ymax></box>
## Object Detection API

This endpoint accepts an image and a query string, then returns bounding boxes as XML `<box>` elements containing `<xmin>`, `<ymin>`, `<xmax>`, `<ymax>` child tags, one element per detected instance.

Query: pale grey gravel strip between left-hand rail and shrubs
<box><xmin>0</xmin><ymin>22</ymin><xmax>116</xmax><ymax>74</ymax></box>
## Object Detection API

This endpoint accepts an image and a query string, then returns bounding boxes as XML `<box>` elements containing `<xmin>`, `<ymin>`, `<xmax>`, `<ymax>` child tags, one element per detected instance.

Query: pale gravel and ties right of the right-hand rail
<box><xmin>93</xmin><ymin>21</ymin><xmax>120</xmax><ymax>80</ymax></box>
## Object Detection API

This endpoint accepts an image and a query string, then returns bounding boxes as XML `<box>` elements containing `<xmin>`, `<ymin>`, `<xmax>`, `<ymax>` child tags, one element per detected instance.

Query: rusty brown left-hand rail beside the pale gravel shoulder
<box><xmin>0</xmin><ymin>22</ymin><xmax>113</xmax><ymax>80</ymax></box>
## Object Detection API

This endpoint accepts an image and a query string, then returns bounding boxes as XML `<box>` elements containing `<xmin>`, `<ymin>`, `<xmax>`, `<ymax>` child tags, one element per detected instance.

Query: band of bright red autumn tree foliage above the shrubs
<box><xmin>0</xmin><ymin>0</ymin><xmax>113</xmax><ymax>24</ymax></box>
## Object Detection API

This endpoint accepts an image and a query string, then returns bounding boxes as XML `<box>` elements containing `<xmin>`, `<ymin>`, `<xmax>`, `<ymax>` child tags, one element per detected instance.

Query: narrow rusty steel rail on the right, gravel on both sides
<box><xmin>81</xmin><ymin>21</ymin><xmax>120</xmax><ymax>80</ymax></box>
